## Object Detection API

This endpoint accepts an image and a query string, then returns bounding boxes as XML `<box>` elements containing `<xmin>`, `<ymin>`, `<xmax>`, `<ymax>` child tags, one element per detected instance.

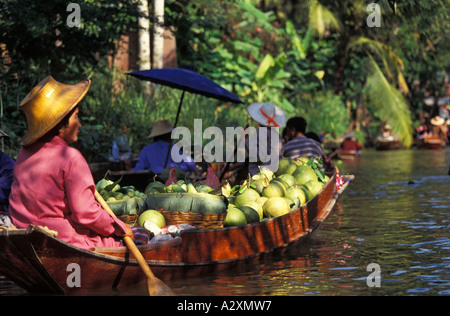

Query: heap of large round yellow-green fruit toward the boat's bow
<box><xmin>222</xmin><ymin>157</ymin><xmax>329</xmax><ymax>226</ymax></box>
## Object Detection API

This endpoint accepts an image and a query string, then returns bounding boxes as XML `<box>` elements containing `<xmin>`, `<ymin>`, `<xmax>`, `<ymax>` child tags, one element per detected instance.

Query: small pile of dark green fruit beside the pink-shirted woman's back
<box><xmin>95</xmin><ymin>178</ymin><xmax>147</xmax><ymax>216</ymax></box>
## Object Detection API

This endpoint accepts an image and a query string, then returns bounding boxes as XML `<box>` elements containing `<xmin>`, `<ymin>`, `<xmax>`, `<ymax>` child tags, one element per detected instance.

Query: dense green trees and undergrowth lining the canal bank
<box><xmin>0</xmin><ymin>0</ymin><xmax>450</xmax><ymax>162</ymax></box>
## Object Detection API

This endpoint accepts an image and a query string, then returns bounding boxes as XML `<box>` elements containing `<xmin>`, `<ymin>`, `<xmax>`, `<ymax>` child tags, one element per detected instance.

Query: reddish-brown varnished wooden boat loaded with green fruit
<box><xmin>0</xmin><ymin>175</ymin><xmax>353</xmax><ymax>294</ymax></box>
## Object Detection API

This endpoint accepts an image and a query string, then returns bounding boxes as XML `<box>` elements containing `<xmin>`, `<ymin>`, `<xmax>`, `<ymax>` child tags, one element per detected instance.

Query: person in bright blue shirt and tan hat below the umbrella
<box><xmin>132</xmin><ymin>120</ymin><xmax>195</xmax><ymax>175</ymax></box>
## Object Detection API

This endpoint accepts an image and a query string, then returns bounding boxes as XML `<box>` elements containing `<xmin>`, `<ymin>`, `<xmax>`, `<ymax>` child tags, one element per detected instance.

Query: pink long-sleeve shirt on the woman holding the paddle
<box><xmin>9</xmin><ymin>136</ymin><xmax>126</xmax><ymax>249</ymax></box>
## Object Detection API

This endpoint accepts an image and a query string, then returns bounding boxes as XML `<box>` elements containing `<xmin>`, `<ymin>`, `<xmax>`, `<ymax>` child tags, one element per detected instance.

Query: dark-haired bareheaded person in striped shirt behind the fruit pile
<box><xmin>283</xmin><ymin>116</ymin><xmax>323</xmax><ymax>159</ymax></box>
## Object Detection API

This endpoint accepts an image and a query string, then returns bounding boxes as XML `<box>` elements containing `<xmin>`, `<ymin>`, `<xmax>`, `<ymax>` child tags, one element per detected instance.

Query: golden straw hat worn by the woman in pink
<box><xmin>20</xmin><ymin>76</ymin><xmax>91</xmax><ymax>146</ymax></box>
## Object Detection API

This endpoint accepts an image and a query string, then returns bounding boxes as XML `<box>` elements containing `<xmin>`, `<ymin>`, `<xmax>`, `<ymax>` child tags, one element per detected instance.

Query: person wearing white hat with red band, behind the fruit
<box><xmin>246</xmin><ymin>102</ymin><xmax>286</xmax><ymax>175</ymax></box>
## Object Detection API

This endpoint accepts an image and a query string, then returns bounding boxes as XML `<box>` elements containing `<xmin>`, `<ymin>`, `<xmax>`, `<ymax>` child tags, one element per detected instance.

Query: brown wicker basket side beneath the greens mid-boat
<box><xmin>158</xmin><ymin>209</ymin><xmax>227</xmax><ymax>229</ymax></box>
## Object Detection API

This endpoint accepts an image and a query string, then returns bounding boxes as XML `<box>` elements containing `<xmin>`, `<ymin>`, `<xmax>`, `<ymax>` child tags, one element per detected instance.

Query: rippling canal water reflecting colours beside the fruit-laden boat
<box><xmin>0</xmin><ymin>148</ymin><xmax>450</xmax><ymax>296</ymax></box>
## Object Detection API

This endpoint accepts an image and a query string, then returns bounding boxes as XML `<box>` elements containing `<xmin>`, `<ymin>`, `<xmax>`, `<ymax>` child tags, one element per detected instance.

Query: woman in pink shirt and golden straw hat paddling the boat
<box><xmin>9</xmin><ymin>76</ymin><xmax>139</xmax><ymax>249</ymax></box>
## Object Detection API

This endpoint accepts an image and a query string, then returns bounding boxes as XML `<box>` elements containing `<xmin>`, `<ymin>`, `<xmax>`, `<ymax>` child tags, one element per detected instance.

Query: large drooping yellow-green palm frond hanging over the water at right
<box><xmin>366</xmin><ymin>54</ymin><xmax>412</xmax><ymax>147</ymax></box>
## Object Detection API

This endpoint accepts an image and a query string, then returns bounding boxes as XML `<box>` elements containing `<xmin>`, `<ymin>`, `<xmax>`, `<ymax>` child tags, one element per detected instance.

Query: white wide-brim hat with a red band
<box><xmin>247</xmin><ymin>102</ymin><xmax>286</xmax><ymax>127</ymax></box>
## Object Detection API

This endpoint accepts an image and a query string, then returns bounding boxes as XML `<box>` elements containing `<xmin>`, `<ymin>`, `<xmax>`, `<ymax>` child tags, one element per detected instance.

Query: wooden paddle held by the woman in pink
<box><xmin>95</xmin><ymin>190</ymin><xmax>175</xmax><ymax>296</ymax></box>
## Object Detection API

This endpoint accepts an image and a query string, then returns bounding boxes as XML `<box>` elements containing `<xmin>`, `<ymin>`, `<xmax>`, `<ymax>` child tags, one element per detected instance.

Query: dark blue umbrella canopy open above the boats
<box><xmin>128</xmin><ymin>68</ymin><xmax>243</xmax><ymax>103</ymax></box>
